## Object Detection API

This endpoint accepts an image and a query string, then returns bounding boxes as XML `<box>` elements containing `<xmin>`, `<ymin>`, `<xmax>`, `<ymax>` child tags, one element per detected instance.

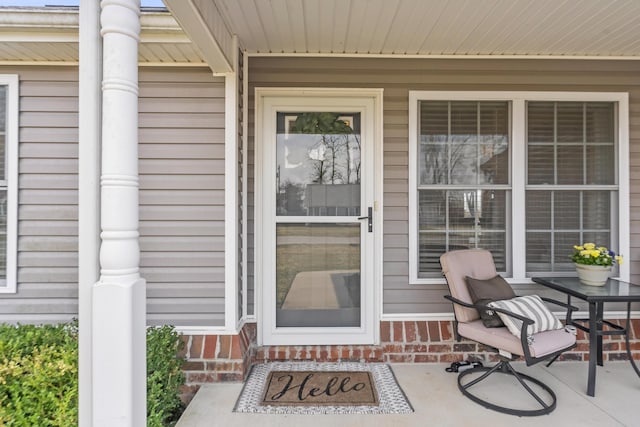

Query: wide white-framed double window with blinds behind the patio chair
<box><xmin>409</xmin><ymin>92</ymin><xmax>629</xmax><ymax>283</ymax></box>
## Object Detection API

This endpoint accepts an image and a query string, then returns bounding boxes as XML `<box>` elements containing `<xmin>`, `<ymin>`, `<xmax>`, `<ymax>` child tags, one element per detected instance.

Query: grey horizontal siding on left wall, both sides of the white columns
<box><xmin>0</xmin><ymin>66</ymin><xmax>225</xmax><ymax>326</ymax></box>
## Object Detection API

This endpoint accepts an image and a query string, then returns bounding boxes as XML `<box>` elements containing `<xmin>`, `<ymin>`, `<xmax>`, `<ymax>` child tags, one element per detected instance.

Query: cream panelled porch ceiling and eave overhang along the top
<box><xmin>0</xmin><ymin>0</ymin><xmax>640</xmax><ymax>73</ymax></box>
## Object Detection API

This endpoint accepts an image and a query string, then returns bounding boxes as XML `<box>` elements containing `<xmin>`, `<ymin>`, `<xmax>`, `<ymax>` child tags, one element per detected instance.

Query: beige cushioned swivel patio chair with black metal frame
<box><xmin>440</xmin><ymin>249</ymin><xmax>577</xmax><ymax>416</ymax></box>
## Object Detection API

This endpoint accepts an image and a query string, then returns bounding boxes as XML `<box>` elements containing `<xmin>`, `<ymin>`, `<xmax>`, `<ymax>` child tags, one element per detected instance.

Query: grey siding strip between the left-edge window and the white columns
<box><xmin>0</xmin><ymin>67</ymin><xmax>78</xmax><ymax>323</ymax></box>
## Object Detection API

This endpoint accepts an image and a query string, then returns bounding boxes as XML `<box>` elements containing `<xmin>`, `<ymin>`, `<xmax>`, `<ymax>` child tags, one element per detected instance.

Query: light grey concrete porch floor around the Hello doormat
<box><xmin>176</xmin><ymin>362</ymin><xmax>640</xmax><ymax>427</ymax></box>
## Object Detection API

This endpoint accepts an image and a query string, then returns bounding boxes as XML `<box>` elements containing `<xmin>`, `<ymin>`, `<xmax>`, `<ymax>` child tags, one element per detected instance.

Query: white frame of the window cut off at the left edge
<box><xmin>0</xmin><ymin>74</ymin><xmax>20</xmax><ymax>293</ymax></box>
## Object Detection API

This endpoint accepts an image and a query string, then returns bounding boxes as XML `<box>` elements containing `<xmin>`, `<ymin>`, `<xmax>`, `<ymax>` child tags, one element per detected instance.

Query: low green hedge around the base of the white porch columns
<box><xmin>0</xmin><ymin>323</ymin><xmax>184</xmax><ymax>427</ymax></box>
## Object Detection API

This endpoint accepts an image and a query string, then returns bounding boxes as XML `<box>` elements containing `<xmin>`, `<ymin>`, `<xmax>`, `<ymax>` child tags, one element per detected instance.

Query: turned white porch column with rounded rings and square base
<box><xmin>93</xmin><ymin>0</ymin><xmax>146</xmax><ymax>427</ymax></box>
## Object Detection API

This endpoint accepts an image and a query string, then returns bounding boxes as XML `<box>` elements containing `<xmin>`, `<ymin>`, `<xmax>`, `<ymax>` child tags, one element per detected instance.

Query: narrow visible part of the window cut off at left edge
<box><xmin>0</xmin><ymin>75</ymin><xmax>18</xmax><ymax>293</ymax></box>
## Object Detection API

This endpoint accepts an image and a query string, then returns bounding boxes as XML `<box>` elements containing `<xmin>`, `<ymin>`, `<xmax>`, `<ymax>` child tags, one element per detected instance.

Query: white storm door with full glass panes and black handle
<box><xmin>256</xmin><ymin>93</ymin><xmax>379</xmax><ymax>345</ymax></box>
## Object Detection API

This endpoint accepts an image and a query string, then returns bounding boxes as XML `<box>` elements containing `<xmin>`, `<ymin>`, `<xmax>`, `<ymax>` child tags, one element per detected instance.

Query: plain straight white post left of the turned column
<box><xmin>78</xmin><ymin>0</ymin><xmax>102</xmax><ymax>427</ymax></box>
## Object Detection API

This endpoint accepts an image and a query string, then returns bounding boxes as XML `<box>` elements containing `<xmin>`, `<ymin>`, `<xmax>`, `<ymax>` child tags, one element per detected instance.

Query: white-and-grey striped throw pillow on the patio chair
<box><xmin>487</xmin><ymin>295</ymin><xmax>563</xmax><ymax>338</ymax></box>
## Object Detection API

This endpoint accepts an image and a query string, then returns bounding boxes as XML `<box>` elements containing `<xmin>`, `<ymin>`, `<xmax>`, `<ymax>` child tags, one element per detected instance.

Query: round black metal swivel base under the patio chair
<box><xmin>458</xmin><ymin>360</ymin><xmax>556</xmax><ymax>417</ymax></box>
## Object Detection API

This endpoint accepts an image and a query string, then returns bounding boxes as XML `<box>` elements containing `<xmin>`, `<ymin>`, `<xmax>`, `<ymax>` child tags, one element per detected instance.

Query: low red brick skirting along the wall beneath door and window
<box><xmin>182</xmin><ymin>319</ymin><xmax>640</xmax><ymax>402</ymax></box>
